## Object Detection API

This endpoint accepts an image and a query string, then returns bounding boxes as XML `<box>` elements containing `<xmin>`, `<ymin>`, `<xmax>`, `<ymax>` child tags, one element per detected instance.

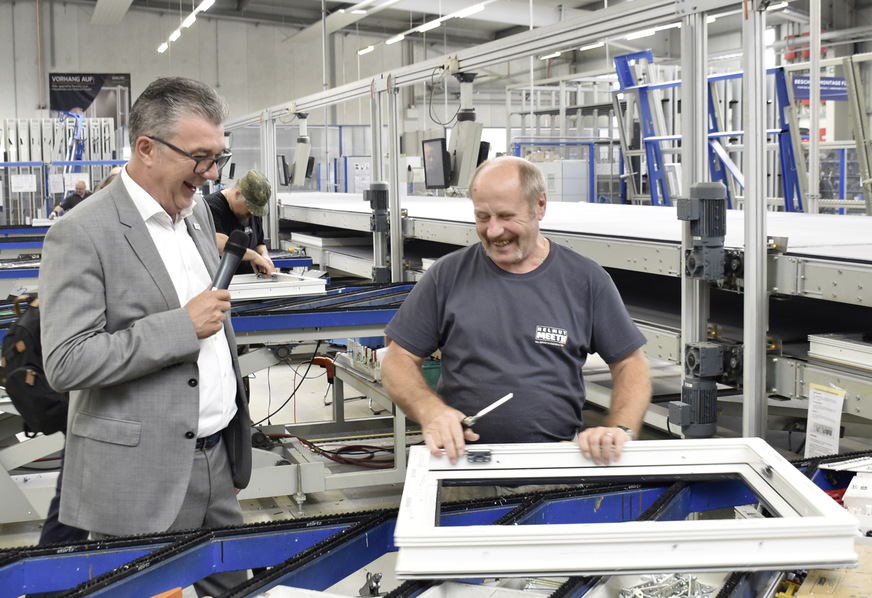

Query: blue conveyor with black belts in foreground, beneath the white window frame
<box><xmin>0</xmin><ymin>452</ymin><xmax>860</xmax><ymax>598</ymax></box>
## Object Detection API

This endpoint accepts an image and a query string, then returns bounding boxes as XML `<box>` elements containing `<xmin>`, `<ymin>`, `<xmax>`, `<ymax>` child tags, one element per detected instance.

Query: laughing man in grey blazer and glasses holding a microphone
<box><xmin>39</xmin><ymin>78</ymin><xmax>251</xmax><ymax>594</ymax></box>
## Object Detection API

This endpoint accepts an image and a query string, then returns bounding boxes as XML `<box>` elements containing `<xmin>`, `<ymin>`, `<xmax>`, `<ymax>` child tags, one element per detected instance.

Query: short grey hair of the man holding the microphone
<box><xmin>130</xmin><ymin>77</ymin><xmax>228</xmax><ymax>145</ymax></box>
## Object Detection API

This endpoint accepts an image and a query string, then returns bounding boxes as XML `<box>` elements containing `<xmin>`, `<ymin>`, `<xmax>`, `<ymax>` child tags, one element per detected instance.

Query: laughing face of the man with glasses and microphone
<box><xmin>128</xmin><ymin>115</ymin><xmax>224</xmax><ymax>219</ymax></box>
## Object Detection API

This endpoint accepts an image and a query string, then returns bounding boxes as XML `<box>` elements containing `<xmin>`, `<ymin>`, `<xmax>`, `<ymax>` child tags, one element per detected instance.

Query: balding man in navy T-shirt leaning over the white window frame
<box><xmin>382</xmin><ymin>157</ymin><xmax>651</xmax><ymax>472</ymax></box>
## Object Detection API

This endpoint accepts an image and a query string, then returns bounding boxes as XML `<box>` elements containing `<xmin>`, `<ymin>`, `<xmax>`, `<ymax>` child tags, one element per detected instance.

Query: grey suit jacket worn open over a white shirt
<box><xmin>39</xmin><ymin>177</ymin><xmax>251</xmax><ymax>535</ymax></box>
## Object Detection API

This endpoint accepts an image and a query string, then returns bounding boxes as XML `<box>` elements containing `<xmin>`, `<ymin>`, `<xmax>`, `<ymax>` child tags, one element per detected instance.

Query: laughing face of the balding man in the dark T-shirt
<box><xmin>471</xmin><ymin>160</ymin><xmax>548</xmax><ymax>274</ymax></box>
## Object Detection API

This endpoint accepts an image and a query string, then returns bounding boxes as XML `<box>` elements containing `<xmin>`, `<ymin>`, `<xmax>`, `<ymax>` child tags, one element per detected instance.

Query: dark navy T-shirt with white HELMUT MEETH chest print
<box><xmin>385</xmin><ymin>242</ymin><xmax>645</xmax><ymax>443</ymax></box>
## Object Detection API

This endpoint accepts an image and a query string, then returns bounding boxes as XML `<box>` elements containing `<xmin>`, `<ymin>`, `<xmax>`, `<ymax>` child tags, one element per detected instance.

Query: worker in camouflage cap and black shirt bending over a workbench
<box><xmin>204</xmin><ymin>170</ymin><xmax>275</xmax><ymax>276</ymax></box>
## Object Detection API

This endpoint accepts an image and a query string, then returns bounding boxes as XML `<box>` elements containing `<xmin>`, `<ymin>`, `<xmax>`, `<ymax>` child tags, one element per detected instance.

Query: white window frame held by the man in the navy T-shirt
<box><xmin>394</xmin><ymin>438</ymin><xmax>857</xmax><ymax>579</ymax></box>
